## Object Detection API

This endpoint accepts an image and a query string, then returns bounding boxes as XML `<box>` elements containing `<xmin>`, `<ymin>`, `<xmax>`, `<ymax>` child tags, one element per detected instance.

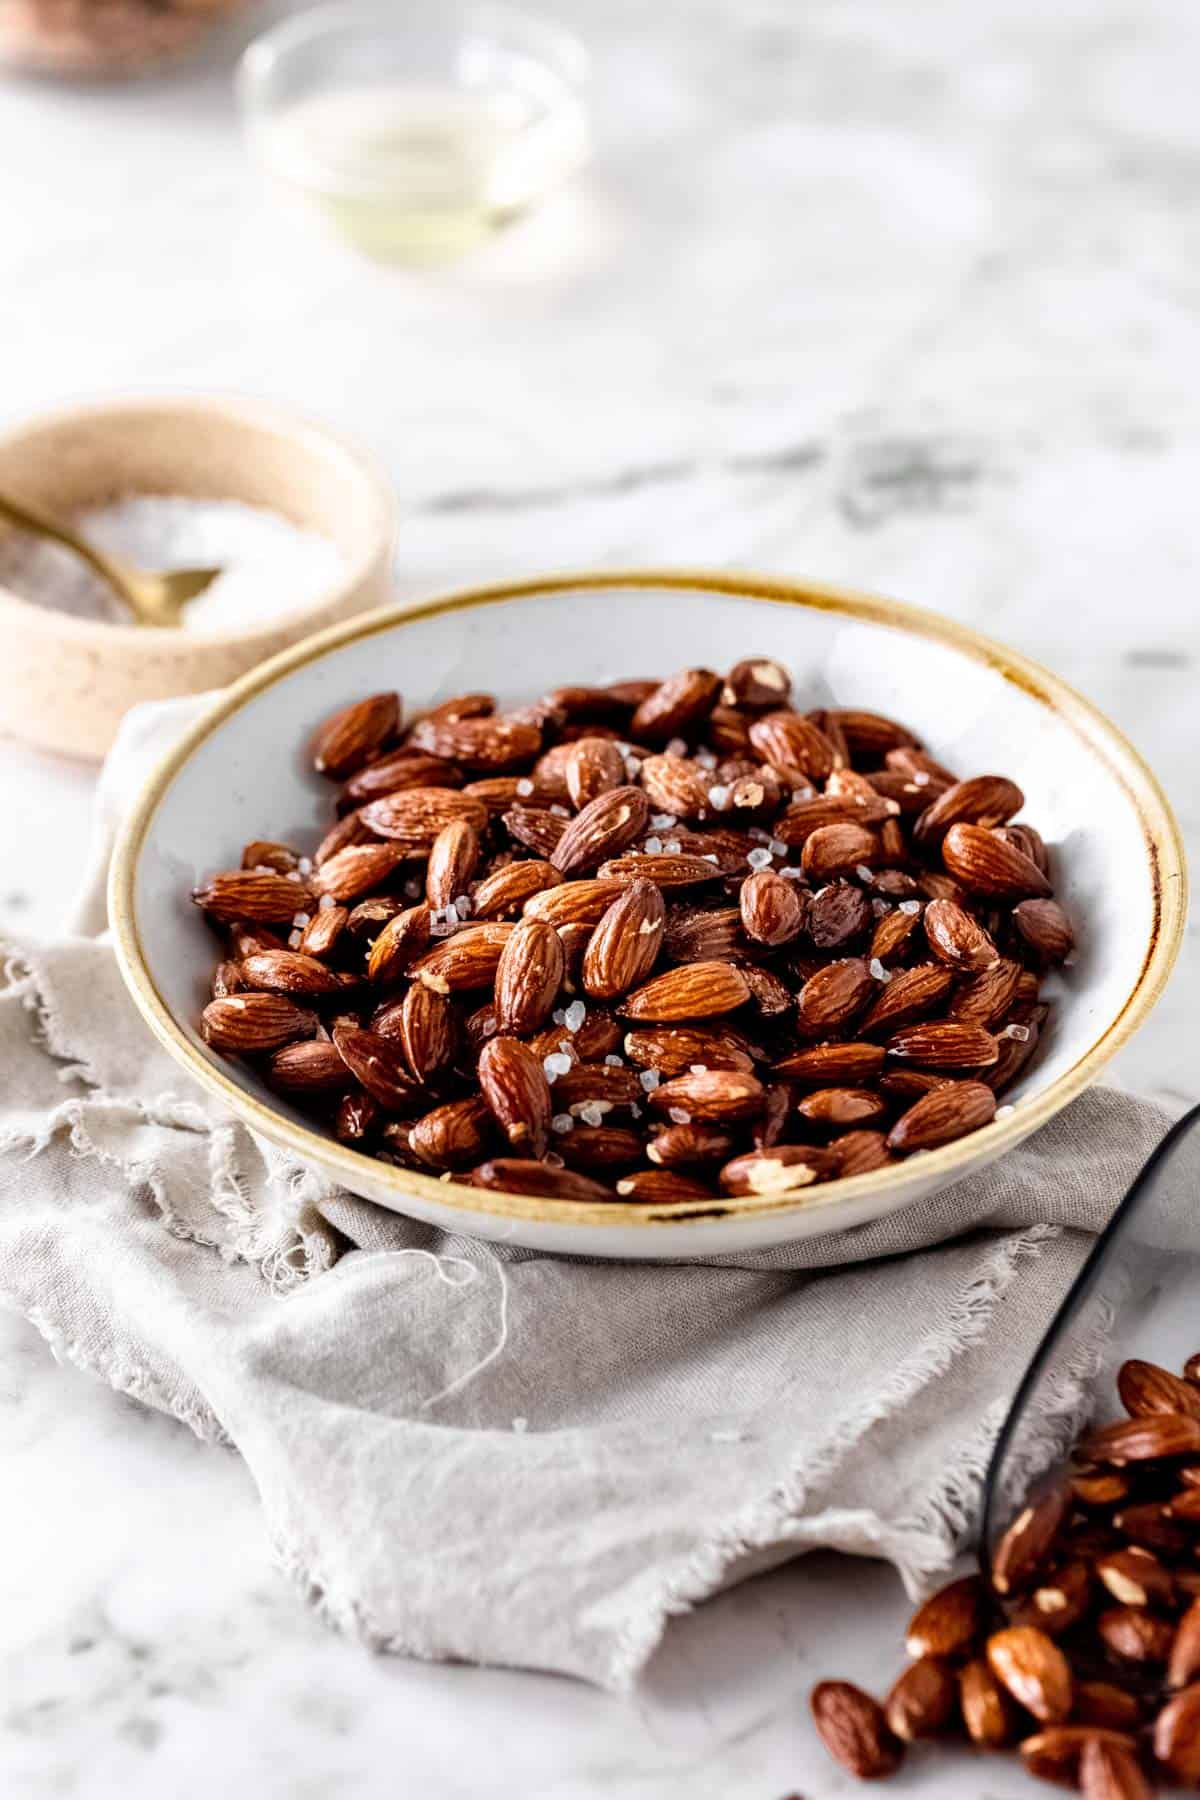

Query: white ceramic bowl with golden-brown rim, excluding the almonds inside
<box><xmin>110</xmin><ymin>572</ymin><xmax>1186</xmax><ymax>1258</ymax></box>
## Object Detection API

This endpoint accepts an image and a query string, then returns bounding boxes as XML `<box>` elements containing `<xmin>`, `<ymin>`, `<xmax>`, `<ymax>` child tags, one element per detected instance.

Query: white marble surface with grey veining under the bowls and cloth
<box><xmin>0</xmin><ymin>0</ymin><xmax>1200</xmax><ymax>1800</ymax></box>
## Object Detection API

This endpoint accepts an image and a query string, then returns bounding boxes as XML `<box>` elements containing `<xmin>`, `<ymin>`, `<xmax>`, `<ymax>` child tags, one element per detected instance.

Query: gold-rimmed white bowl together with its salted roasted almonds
<box><xmin>110</xmin><ymin>574</ymin><xmax>1184</xmax><ymax>1258</ymax></box>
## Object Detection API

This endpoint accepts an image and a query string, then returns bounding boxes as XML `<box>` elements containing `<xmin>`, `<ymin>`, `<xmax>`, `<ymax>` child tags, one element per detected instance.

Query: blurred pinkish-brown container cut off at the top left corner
<box><xmin>0</xmin><ymin>0</ymin><xmax>250</xmax><ymax>79</ymax></box>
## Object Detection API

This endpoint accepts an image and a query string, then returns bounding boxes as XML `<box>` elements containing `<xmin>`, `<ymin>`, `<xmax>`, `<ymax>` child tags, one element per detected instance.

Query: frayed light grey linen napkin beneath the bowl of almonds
<box><xmin>0</xmin><ymin>702</ymin><xmax>1168</xmax><ymax>1688</ymax></box>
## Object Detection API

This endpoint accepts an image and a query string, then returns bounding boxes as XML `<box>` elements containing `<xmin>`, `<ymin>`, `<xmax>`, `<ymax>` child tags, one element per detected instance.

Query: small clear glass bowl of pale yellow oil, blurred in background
<box><xmin>237</xmin><ymin>0</ymin><xmax>588</xmax><ymax>261</ymax></box>
